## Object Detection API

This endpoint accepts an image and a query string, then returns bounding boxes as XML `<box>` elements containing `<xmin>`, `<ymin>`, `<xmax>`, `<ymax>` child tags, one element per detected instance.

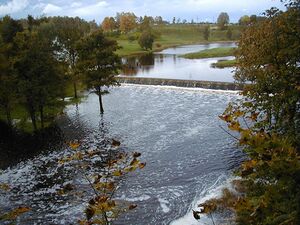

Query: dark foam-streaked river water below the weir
<box><xmin>0</xmin><ymin>85</ymin><xmax>242</xmax><ymax>225</ymax></box>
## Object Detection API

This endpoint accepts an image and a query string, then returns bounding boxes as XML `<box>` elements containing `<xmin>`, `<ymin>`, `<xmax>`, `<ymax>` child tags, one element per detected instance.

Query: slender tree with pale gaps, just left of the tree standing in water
<box><xmin>52</xmin><ymin>17</ymin><xmax>90</xmax><ymax>98</ymax></box>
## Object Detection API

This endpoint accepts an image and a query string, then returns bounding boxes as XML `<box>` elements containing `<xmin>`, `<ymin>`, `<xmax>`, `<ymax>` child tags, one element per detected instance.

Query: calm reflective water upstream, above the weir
<box><xmin>121</xmin><ymin>42</ymin><xmax>236</xmax><ymax>82</ymax></box>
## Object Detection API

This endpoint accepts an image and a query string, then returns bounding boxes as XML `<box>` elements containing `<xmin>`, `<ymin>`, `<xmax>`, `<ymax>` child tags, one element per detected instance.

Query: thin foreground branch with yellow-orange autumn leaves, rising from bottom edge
<box><xmin>59</xmin><ymin>140</ymin><xmax>146</xmax><ymax>225</ymax></box>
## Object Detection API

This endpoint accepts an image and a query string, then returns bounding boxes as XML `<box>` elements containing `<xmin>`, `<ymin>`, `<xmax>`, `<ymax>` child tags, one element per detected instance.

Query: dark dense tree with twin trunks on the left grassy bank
<box><xmin>14</xmin><ymin>31</ymin><xmax>61</xmax><ymax>131</ymax></box>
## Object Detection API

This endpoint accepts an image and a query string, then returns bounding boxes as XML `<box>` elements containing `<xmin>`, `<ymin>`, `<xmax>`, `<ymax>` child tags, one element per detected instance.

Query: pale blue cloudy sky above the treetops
<box><xmin>0</xmin><ymin>0</ymin><xmax>284</xmax><ymax>22</ymax></box>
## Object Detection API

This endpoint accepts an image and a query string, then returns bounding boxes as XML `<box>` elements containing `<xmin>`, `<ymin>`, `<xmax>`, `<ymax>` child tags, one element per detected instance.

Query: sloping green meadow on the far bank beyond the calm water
<box><xmin>115</xmin><ymin>24</ymin><xmax>241</xmax><ymax>56</ymax></box>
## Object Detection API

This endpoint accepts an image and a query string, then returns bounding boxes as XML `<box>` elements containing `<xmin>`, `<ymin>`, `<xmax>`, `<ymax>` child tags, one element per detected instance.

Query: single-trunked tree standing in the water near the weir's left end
<box><xmin>77</xmin><ymin>31</ymin><xmax>121</xmax><ymax>114</ymax></box>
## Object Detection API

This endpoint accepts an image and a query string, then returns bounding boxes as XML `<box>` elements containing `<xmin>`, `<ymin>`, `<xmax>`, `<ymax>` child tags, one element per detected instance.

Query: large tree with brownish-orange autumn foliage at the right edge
<box><xmin>235</xmin><ymin>8</ymin><xmax>300</xmax><ymax>140</ymax></box>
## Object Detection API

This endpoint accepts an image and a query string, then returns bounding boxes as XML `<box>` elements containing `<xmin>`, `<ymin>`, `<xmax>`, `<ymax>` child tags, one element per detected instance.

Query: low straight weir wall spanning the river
<box><xmin>117</xmin><ymin>76</ymin><xmax>242</xmax><ymax>91</ymax></box>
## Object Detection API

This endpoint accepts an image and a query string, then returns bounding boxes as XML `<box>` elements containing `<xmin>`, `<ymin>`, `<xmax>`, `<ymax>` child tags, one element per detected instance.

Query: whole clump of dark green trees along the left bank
<box><xmin>0</xmin><ymin>16</ymin><xmax>120</xmax><ymax>131</ymax></box>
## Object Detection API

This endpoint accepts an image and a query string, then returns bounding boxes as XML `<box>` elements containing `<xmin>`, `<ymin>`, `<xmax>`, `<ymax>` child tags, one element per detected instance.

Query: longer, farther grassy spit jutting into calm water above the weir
<box><xmin>181</xmin><ymin>47</ymin><xmax>236</xmax><ymax>59</ymax></box>
